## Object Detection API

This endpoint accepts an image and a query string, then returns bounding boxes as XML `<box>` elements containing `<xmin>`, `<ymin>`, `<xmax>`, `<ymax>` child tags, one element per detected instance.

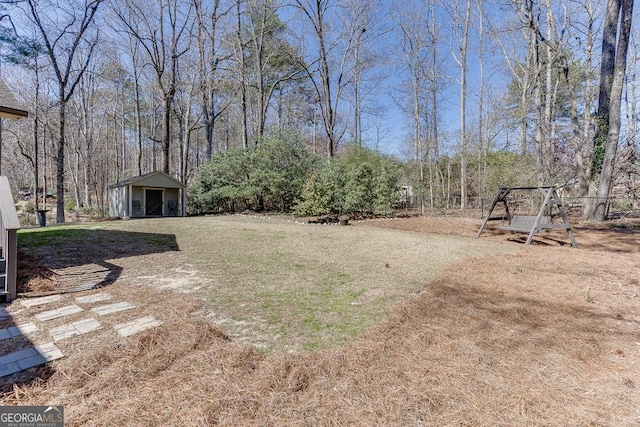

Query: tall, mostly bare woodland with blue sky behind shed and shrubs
<box><xmin>0</xmin><ymin>0</ymin><xmax>640</xmax><ymax>222</ymax></box>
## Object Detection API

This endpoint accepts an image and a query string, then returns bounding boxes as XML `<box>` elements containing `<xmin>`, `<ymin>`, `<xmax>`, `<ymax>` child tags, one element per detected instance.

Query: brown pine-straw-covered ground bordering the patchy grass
<box><xmin>0</xmin><ymin>217</ymin><xmax>640</xmax><ymax>426</ymax></box>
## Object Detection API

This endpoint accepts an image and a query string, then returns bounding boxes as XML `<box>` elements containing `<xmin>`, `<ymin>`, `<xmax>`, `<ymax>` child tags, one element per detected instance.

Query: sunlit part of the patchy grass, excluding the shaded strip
<box><xmin>127</xmin><ymin>216</ymin><xmax>506</xmax><ymax>351</ymax></box>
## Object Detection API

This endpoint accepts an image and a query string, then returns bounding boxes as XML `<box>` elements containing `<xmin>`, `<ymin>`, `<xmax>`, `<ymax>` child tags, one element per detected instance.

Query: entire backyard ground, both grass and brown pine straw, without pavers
<box><xmin>0</xmin><ymin>215</ymin><xmax>640</xmax><ymax>426</ymax></box>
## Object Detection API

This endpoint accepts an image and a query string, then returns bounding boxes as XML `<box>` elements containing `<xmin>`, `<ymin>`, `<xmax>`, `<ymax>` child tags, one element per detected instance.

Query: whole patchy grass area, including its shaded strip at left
<box><xmin>20</xmin><ymin>216</ymin><xmax>508</xmax><ymax>351</ymax></box>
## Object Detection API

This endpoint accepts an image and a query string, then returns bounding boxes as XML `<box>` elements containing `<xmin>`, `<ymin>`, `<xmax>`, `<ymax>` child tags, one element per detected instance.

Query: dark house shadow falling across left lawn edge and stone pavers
<box><xmin>0</xmin><ymin>227</ymin><xmax>179</xmax><ymax>392</ymax></box>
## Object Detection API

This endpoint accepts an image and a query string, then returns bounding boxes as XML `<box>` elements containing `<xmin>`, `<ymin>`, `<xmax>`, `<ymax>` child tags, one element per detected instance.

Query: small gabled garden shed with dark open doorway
<box><xmin>109</xmin><ymin>171</ymin><xmax>186</xmax><ymax>219</ymax></box>
